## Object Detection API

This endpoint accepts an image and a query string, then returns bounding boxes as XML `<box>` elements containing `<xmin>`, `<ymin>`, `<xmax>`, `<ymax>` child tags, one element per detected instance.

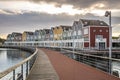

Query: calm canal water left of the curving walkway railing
<box><xmin>0</xmin><ymin>48</ymin><xmax>31</xmax><ymax>80</ymax></box>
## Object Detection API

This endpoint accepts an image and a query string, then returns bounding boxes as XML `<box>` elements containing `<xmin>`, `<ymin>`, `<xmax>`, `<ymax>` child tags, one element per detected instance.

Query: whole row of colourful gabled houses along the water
<box><xmin>7</xmin><ymin>19</ymin><xmax>109</xmax><ymax>47</ymax></box>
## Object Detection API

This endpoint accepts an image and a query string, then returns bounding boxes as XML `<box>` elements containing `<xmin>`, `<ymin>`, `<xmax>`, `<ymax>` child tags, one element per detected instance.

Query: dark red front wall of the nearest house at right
<box><xmin>90</xmin><ymin>27</ymin><xmax>109</xmax><ymax>47</ymax></box>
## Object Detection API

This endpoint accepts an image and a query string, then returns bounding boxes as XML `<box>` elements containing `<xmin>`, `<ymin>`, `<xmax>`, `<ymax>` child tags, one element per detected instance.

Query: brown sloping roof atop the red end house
<box><xmin>80</xmin><ymin>19</ymin><xmax>108</xmax><ymax>27</ymax></box>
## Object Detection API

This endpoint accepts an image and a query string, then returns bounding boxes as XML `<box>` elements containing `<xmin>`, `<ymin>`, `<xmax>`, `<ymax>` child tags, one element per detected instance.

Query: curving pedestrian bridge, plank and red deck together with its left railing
<box><xmin>0</xmin><ymin>48</ymin><xmax>120</xmax><ymax>80</ymax></box>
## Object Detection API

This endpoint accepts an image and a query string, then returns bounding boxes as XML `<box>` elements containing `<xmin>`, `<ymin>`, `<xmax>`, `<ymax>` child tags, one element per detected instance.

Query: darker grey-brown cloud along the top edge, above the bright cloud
<box><xmin>29</xmin><ymin>0</ymin><xmax>120</xmax><ymax>8</ymax></box>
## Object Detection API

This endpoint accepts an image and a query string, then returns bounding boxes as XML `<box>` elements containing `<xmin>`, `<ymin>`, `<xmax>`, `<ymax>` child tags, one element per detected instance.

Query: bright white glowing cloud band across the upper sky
<box><xmin>0</xmin><ymin>1</ymin><xmax>120</xmax><ymax>16</ymax></box>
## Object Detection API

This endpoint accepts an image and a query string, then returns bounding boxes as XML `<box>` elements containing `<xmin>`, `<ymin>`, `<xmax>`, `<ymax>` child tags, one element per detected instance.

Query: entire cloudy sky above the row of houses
<box><xmin>0</xmin><ymin>0</ymin><xmax>120</xmax><ymax>38</ymax></box>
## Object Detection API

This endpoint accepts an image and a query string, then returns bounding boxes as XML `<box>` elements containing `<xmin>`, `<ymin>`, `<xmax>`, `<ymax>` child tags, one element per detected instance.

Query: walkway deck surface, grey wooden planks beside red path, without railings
<box><xmin>27</xmin><ymin>48</ymin><xmax>120</xmax><ymax>80</ymax></box>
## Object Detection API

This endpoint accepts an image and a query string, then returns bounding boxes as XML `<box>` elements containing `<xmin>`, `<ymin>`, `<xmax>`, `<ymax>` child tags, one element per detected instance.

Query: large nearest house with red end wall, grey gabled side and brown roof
<box><xmin>72</xmin><ymin>19</ymin><xmax>109</xmax><ymax>48</ymax></box>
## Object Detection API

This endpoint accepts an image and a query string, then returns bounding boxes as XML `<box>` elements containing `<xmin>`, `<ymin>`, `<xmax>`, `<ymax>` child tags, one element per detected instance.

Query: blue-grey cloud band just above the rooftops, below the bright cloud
<box><xmin>0</xmin><ymin>13</ymin><xmax>120</xmax><ymax>33</ymax></box>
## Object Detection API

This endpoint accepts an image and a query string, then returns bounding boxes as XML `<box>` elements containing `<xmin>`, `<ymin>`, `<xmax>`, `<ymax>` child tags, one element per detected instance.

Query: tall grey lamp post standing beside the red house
<box><xmin>105</xmin><ymin>11</ymin><xmax>112</xmax><ymax>74</ymax></box>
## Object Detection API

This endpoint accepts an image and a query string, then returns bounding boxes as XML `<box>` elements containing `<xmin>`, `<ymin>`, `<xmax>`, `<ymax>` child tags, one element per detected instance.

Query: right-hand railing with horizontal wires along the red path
<box><xmin>64</xmin><ymin>50</ymin><xmax>120</xmax><ymax>78</ymax></box>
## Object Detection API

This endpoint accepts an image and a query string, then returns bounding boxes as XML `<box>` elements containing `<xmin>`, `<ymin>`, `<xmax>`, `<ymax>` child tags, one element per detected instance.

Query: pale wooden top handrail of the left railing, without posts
<box><xmin>0</xmin><ymin>48</ymin><xmax>38</xmax><ymax>79</ymax></box>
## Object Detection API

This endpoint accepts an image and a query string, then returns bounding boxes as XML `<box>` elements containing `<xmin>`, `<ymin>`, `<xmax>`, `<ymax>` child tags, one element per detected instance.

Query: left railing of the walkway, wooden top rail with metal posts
<box><xmin>0</xmin><ymin>49</ymin><xmax>38</xmax><ymax>80</ymax></box>
